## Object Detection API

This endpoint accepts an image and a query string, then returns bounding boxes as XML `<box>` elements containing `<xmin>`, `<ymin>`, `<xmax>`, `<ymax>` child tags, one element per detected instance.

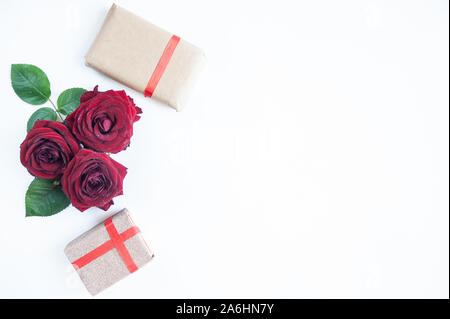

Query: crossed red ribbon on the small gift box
<box><xmin>72</xmin><ymin>217</ymin><xmax>140</xmax><ymax>273</ymax></box>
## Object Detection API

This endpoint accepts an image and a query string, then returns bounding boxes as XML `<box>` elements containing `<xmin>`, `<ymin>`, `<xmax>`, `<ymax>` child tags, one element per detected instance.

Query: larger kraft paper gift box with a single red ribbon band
<box><xmin>85</xmin><ymin>4</ymin><xmax>206</xmax><ymax>111</ymax></box>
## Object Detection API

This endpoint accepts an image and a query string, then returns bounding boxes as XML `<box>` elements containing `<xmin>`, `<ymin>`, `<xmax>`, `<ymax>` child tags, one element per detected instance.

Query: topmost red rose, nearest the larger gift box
<box><xmin>66</xmin><ymin>85</ymin><xmax>142</xmax><ymax>153</ymax></box>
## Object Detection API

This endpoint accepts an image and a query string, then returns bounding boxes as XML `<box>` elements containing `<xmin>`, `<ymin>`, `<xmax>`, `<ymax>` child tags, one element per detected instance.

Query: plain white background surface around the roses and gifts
<box><xmin>0</xmin><ymin>0</ymin><xmax>449</xmax><ymax>298</ymax></box>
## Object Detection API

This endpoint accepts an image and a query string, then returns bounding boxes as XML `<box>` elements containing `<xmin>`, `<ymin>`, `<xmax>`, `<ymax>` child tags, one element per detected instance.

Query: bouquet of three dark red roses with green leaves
<box><xmin>11</xmin><ymin>64</ymin><xmax>142</xmax><ymax>216</ymax></box>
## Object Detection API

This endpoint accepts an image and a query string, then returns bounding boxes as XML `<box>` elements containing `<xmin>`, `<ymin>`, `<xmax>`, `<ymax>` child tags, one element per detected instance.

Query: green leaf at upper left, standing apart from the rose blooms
<box><xmin>11</xmin><ymin>64</ymin><xmax>50</xmax><ymax>105</ymax></box>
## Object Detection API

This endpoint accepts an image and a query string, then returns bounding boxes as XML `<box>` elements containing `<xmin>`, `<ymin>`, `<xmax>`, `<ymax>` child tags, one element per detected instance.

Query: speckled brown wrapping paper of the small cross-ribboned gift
<box><xmin>64</xmin><ymin>209</ymin><xmax>153</xmax><ymax>295</ymax></box>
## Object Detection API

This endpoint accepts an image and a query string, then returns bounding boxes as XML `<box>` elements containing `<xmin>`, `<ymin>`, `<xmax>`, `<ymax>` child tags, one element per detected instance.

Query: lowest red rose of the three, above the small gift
<box><xmin>61</xmin><ymin>149</ymin><xmax>127</xmax><ymax>212</ymax></box>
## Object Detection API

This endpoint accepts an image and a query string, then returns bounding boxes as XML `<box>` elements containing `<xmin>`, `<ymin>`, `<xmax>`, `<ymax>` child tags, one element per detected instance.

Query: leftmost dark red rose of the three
<box><xmin>20</xmin><ymin>120</ymin><xmax>80</xmax><ymax>179</ymax></box>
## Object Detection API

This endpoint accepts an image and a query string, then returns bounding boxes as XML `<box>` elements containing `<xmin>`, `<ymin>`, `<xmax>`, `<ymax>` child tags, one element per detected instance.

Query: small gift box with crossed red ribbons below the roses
<box><xmin>64</xmin><ymin>209</ymin><xmax>153</xmax><ymax>295</ymax></box>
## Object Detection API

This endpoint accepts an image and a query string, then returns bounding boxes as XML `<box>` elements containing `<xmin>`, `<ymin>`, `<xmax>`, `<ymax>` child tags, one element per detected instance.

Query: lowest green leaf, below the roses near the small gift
<box><xmin>25</xmin><ymin>178</ymin><xmax>70</xmax><ymax>217</ymax></box>
